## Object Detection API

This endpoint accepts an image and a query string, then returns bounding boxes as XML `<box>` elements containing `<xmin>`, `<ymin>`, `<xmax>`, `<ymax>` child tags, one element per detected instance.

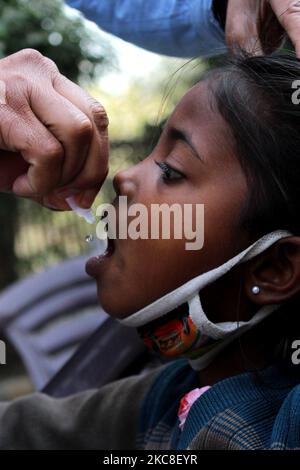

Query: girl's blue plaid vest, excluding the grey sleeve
<box><xmin>136</xmin><ymin>360</ymin><xmax>300</xmax><ymax>450</ymax></box>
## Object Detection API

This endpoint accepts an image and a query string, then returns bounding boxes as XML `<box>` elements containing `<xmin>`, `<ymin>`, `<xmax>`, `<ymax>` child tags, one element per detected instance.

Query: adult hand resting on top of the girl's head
<box><xmin>225</xmin><ymin>0</ymin><xmax>300</xmax><ymax>58</ymax></box>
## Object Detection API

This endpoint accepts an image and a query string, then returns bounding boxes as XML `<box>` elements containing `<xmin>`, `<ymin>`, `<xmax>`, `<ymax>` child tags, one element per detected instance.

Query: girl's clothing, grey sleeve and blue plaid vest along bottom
<box><xmin>0</xmin><ymin>360</ymin><xmax>300</xmax><ymax>450</ymax></box>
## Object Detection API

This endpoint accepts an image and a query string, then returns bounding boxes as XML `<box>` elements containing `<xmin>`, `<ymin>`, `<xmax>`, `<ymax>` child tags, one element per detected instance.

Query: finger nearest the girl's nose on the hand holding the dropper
<box><xmin>54</xmin><ymin>76</ymin><xmax>109</xmax><ymax>204</ymax></box>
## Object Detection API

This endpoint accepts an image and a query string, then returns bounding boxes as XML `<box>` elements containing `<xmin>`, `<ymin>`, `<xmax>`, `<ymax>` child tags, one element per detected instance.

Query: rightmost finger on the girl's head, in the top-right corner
<box><xmin>270</xmin><ymin>0</ymin><xmax>300</xmax><ymax>58</ymax></box>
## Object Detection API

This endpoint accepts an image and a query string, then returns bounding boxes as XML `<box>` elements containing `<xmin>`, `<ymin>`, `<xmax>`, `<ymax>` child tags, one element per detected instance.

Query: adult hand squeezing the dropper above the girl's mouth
<box><xmin>0</xmin><ymin>49</ymin><xmax>109</xmax><ymax>209</ymax></box>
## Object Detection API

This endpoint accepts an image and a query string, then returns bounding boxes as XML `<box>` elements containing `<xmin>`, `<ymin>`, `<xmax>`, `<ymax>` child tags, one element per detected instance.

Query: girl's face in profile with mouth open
<box><xmin>87</xmin><ymin>81</ymin><xmax>253</xmax><ymax>318</ymax></box>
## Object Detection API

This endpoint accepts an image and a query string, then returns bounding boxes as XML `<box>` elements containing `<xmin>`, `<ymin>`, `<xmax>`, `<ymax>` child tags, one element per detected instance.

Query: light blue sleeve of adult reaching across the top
<box><xmin>66</xmin><ymin>0</ymin><xmax>226</xmax><ymax>57</ymax></box>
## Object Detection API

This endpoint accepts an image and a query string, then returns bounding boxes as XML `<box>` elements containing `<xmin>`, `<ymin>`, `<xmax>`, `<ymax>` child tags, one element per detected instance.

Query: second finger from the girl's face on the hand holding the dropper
<box><xmin>30</xmin><ymin>87</ymin><xmax>93</xmax><ymax>185</ymax></box>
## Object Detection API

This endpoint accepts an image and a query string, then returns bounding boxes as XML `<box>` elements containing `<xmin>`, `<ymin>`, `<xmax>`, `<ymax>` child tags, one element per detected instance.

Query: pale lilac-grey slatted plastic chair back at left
<box><xmin>0</xmin><ymin>254</ymin><xmax>108</xmax><ymax>390</ymax></box>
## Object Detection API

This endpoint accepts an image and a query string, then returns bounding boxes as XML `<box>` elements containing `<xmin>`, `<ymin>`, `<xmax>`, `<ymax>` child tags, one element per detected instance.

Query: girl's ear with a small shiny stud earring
<box><xmin>244</xmin><ymin>237</ymin><xmax>300</xmax><ymax>305</ymax></box>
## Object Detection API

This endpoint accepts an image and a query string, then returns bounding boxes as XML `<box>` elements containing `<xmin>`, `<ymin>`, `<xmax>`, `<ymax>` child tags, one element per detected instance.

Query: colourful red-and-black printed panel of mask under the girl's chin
<box><xmin>137</xmin><ymin>302</ymin><xmax>219</xmax><ymax>359</ymax></box>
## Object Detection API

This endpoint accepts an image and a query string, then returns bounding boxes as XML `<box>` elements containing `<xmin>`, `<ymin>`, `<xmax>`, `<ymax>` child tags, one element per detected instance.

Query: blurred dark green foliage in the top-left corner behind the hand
<box><xmin>0</xmin><ymin>0</ymin><xmax>113</xmax><ymax>81</ymax></box>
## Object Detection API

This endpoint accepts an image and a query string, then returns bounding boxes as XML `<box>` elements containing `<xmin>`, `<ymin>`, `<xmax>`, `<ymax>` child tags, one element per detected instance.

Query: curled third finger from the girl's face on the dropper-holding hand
<box><xmin>0</xmin><ymin>103</ymin><xmax>64</xmax><ymax>197</ymax></box>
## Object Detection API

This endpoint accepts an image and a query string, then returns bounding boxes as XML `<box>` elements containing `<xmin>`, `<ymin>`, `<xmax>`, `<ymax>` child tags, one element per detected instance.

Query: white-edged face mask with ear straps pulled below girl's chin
<box><xmin>119</xmin><ymin>230</ymin><xmax>293</xmax><ymax>370</ymax></box>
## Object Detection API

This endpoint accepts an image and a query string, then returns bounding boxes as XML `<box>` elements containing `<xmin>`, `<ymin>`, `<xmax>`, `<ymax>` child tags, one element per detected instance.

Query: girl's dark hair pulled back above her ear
<box><xmin>206</xmin><ymin>53</ymin><xmax>300</xmax><ymax>368</ymax></box>
